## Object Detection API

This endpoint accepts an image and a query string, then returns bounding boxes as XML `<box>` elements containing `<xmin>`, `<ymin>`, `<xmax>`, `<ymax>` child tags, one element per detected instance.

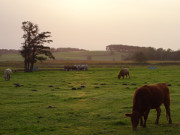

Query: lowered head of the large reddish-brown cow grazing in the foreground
<box><xmin>125</xmin><ymin>112</ymin><xmax>141</xmax><ymax>130</ymax></box>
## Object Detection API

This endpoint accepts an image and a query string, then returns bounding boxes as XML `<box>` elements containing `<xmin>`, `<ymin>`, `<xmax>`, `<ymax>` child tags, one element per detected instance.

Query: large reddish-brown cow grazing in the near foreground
<box><xmin>125</xmin><ymin>83</ymin><xmax>172</xmax><ymax>129</ymax></box>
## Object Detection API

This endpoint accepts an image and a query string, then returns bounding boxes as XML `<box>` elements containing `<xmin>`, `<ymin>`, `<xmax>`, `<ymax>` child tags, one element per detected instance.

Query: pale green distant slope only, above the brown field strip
<box><xmin>0</xmin><ymin>51</ymin><xmax>125</xmax><ymax>61</ymax></box>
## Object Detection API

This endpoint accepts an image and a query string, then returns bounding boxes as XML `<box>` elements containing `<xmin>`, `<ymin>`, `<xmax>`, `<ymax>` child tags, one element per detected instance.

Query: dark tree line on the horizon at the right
<box><xmin>106</xmin><ymin>45</ymin><xmax>180</xmax><ymax>62</ymax></box>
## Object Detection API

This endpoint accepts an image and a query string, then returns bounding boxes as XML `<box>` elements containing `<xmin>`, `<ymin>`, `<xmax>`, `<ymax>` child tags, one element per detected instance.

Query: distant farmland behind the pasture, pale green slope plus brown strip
<box><xmin>0</xmin><ymin>51</ymin><xmax>180</xmax><ymax>69</ymax></box>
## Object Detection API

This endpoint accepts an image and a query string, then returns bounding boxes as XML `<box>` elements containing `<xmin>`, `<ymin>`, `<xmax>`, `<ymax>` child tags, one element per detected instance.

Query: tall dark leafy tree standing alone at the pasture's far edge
<box><xmin>20</xmin><ymin>21</ymin><xmax>55</xmax><ymax>72</ymax></box>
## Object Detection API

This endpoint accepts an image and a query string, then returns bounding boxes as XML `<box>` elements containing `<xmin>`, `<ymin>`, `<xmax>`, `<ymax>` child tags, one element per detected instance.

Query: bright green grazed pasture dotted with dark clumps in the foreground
<box><xmin>0</xmin><ymin>66</ymin><xmax>180</xmax><ymax>135</ymax></box>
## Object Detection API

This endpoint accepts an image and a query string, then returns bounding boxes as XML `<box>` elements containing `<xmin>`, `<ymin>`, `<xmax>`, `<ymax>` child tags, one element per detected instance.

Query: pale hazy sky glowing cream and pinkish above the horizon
<box><xmin>0</xmin><ymin>0</ymin><xmax>180</xmax><ymax>50</ymax></box>
